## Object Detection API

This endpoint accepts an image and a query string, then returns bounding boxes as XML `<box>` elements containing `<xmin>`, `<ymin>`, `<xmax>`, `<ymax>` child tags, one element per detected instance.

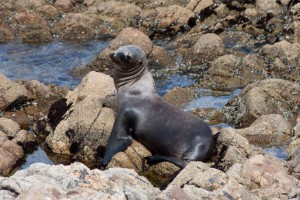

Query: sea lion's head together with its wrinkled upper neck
<box><xmin>110</xmin><ymin>45</ymin><xmax>147</xmax><ymax>89</ymax></box>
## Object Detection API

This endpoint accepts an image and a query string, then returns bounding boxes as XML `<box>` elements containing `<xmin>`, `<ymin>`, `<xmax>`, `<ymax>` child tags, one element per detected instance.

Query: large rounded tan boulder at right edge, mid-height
<box><xmin>224</xmin><ymin>79</ymin><xmax>300</xmax><ymax>127</ymax></box>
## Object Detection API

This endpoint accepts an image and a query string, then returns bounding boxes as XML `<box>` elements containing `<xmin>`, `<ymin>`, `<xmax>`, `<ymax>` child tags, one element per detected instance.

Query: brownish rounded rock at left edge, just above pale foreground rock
<box><xmin>0</xmin><ymin>140</ymin><xmax>24</xmax><ymax>176</ymax></box>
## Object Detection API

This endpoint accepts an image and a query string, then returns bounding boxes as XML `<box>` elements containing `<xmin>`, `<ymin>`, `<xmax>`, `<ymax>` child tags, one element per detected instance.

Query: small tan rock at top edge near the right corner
<box><xmin>255</xmin><ymin>0</ymin><xmax>283</xmax><ymax>15</ymax></box>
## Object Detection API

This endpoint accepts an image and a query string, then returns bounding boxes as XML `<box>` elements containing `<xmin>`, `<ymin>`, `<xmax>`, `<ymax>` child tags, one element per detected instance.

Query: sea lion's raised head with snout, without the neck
<box><xmin>110</xmin><ymin>45</ymin><xmax>147</xmax><ymax>70</ymax></box>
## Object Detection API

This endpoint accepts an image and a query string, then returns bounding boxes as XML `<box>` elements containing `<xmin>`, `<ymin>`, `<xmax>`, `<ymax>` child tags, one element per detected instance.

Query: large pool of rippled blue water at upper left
<box><xmin>0</xmin><ymin>40</ymin><xmax>108</xmax><ymax>88</ymax></box>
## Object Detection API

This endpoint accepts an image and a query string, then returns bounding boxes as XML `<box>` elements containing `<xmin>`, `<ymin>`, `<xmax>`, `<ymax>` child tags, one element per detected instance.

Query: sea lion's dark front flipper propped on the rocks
<box><xmin>102</xmin><ymin>111</ymin><xmax>132</xmax><ymax>165</ymax></box>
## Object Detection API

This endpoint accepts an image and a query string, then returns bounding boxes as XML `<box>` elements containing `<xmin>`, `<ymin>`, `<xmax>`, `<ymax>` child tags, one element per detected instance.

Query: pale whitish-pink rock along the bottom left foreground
<box><xmin>0</xmin><ymin>162</ymin><xmax>160</xmax><ymax>200</ymax></box>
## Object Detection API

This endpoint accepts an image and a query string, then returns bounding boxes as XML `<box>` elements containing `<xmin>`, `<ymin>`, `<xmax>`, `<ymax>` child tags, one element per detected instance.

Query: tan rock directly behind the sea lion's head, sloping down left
<box><xmin>71</xmin><ymin>27</ymin><xmax>153</xmax><ymax>77</ymax></box>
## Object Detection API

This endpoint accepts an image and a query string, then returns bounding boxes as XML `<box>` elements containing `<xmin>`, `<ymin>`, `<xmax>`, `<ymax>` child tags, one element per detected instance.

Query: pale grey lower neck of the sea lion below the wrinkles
<box><xmin>115</xmin><ymin>67</ymin><xmax>158</xmax><ymax>98</ymax></box>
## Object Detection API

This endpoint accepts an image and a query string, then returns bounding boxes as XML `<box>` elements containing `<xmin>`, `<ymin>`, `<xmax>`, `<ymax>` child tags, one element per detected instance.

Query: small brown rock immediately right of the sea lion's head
<box><xmin>149</xmin><ymin>45</ymin><xmax>176</xmax><ymax>70</ymax></box>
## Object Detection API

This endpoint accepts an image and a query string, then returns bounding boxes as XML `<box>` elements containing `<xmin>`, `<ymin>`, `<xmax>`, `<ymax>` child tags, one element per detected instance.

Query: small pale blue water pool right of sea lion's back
<box><xmin>184</xmin><ymin>89</ymin><xmax>242</xmax><ymax>111</ymax></box>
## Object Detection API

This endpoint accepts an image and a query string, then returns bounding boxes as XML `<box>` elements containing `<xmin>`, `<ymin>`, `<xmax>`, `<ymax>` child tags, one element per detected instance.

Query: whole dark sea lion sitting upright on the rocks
<box><xmin>103</xmin><ymin>45</ymin><xmax>214</xmax><ymax>168</ymax></box>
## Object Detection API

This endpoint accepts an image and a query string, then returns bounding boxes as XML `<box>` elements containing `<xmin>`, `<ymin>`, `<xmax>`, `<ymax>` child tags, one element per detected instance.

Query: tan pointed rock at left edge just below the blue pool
<box><xmin>0</xmin><ymin>74</ymin><xmax>33</xmax><ymax>111</ymax></box>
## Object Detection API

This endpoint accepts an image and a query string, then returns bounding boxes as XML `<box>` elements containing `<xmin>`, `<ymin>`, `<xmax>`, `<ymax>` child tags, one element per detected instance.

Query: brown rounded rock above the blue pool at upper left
<box><xmin>51</xmin><ymin>13</ymin><xmax>97</xmax><ymax>40</ymax></box>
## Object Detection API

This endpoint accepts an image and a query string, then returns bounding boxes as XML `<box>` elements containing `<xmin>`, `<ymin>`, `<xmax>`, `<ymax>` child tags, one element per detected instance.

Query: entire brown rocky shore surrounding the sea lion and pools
<box><xmin>0</xmin><ymin>0</ymin><xmax>300</xmax><ymax>200</ymax></box>
